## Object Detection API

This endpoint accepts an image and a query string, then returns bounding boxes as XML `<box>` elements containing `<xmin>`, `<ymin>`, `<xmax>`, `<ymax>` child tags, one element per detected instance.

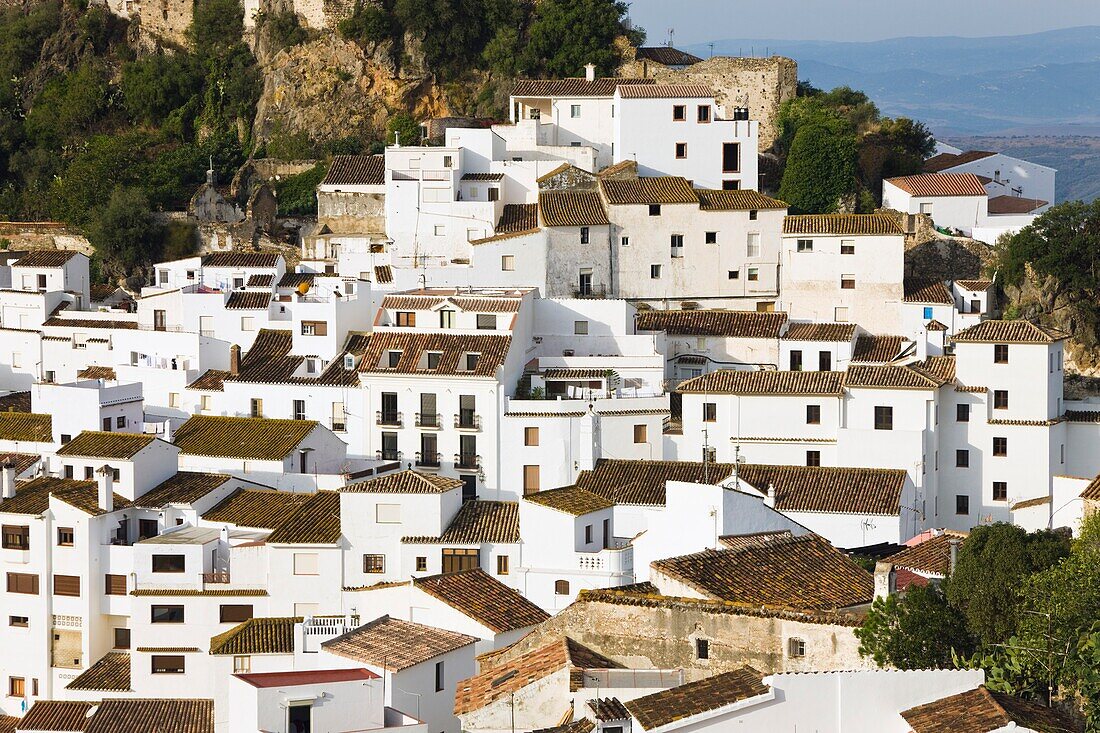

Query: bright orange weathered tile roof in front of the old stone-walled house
<box><xmin>454</xmin><ymin>637</ymin><xmax>622</xmax><ymax>715</ymax></box>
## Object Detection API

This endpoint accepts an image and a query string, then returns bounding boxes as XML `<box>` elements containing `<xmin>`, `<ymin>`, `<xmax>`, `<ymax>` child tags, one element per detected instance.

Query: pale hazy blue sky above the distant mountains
<box><xmin>629</xmin><ymin>0</ymin><xmax>1100</xmax><ymax>45</ymax></box>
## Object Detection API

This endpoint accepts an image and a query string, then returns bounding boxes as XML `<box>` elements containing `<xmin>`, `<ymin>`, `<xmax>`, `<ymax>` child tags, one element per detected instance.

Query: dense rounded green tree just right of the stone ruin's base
<box><xmin>779</xmin><ymin>122</ymin><xmax>857</xmax><ymax>214</ymax></box>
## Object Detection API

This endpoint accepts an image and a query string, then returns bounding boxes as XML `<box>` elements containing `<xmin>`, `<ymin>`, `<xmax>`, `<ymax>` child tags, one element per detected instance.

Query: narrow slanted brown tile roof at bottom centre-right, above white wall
<box><xmin>626</xmin><ymin>667</ymin><xmax>771</xmax><ymax>731</ymax></box>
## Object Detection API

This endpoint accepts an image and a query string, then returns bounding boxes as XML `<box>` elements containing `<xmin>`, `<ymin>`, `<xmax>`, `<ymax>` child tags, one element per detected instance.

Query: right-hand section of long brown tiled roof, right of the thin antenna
<box><xmin>737</xmin><ymin>463</ymin><xmax>906</xmax><ymax>516</ymax></box>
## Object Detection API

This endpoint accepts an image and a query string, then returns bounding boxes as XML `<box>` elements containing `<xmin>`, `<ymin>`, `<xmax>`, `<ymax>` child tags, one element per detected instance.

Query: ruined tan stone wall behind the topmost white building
<box><xmin>619</xmin><ymin>56</ymin><xmax>799</xmax><ymax>152</ymax></box>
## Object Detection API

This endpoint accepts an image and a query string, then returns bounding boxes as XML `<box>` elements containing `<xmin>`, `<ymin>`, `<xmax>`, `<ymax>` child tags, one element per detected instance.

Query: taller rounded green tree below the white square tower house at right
<box><xmin>947</xmin><ymin>522</ymin><xmax>1069</xmax><ymax>645</ymax></box>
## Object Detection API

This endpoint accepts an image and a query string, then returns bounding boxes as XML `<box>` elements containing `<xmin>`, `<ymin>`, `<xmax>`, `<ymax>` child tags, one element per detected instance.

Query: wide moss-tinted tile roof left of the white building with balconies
<box><xmin>175</xmin><ymin>415</ymin><xmax>317</xmax><ymax>461</ymax></box>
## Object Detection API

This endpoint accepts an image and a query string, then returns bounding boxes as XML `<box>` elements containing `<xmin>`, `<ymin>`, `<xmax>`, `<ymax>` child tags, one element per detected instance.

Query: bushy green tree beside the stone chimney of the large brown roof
<box><xmin>856</xmin><ymin>586</ymin><xmax>975</xmax><ymax>669</ymax></box>
